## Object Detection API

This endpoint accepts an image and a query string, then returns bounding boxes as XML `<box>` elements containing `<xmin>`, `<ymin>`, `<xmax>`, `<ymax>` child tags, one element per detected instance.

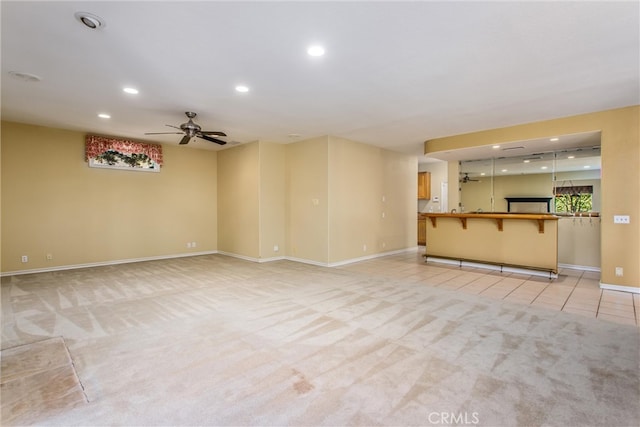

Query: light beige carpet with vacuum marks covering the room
<box><xmin>2</xmin><ymin>255</ymin><xmax>640</xmax><ymax>426</ymax></box>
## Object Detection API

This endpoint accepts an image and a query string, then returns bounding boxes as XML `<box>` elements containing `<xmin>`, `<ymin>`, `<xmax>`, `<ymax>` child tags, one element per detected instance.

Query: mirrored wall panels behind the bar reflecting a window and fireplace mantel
<box><xmin>458</xmin><ymin>145</ymin><xmax>601</xmax><ymax>214</ymax></box>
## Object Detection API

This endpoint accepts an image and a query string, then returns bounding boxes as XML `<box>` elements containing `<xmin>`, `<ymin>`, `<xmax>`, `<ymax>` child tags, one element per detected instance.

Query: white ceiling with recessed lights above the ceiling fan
<box><xmin>1</xmin><ymin>0</ymin><xmax>640</xmax><ymax>162</ymax></box>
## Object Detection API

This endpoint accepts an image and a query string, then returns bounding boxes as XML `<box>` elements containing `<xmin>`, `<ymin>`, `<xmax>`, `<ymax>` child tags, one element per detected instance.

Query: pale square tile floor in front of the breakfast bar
<box><xmin>341</xmin><ymin>251</ymin><xmax>640</xmax><ymax>326</ymax></box>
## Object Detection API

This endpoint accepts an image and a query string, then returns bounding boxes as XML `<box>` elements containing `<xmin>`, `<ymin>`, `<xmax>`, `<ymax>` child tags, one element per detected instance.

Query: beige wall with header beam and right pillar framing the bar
<box><xmin>425</xmin><ymin>106</ymin><xmax>640</xmax><ymax>290</ymax></box>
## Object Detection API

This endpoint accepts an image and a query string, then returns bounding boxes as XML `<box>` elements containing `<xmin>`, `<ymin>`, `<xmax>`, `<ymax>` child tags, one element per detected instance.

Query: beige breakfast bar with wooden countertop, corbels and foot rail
<box><xmin>420</xmin><ymin>212</ymin><xmax>559</xmax><ymax>274</ymax></box>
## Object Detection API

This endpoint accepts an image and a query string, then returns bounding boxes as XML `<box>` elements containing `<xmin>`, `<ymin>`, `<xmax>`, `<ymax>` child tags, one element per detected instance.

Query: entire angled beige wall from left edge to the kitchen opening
<box><xmin>2</xmin><ymin>123</ymin><xmax>417</xmax><ymax>273</ymax></box>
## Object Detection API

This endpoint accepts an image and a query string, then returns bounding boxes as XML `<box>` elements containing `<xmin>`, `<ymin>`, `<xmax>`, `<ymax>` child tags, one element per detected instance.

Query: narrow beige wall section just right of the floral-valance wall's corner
<box><xmin>217</xmin><ymin>142</ymin><xmax>260</xmax><ymax>259</ymax></box>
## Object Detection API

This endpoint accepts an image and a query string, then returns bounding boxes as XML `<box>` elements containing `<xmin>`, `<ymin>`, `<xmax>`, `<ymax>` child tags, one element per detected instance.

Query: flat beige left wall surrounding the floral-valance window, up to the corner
<box><xmin>1</xmin><ymin>122</ymin><xmax>218</xmax><ymax>272</ymax></box>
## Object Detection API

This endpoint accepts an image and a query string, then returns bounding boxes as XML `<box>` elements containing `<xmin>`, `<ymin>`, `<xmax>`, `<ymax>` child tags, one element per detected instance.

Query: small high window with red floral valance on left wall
<box><xmin>85</xmin><ymin>135</ymin><xmax>162</xmax><ymax>172</ymax></box>
